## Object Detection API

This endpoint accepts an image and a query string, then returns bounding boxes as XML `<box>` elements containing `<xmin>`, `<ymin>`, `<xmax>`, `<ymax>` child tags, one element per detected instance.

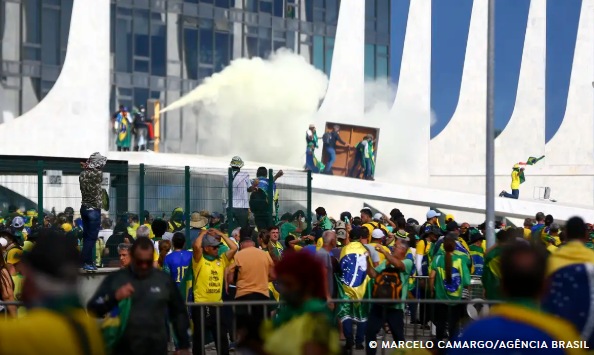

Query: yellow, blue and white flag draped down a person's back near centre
<box><xmin>337</xmin><ymin>242</ymin><xmax>370</xmax><ymax>322</ymax></box>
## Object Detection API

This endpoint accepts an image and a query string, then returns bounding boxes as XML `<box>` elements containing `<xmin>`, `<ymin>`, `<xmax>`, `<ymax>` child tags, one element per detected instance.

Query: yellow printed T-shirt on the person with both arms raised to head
<box><xmin>192</xmin><ymin>254</ymin><xmax>231</xmax><ymax>303</ymax></box>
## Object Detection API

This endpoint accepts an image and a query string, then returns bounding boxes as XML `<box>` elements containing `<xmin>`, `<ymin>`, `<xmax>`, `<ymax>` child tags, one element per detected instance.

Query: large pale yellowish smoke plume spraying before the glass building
<box><xmin>162</xmin><ymin>49</ymin><xmax>328</xmax><ymax>167</ymax></box>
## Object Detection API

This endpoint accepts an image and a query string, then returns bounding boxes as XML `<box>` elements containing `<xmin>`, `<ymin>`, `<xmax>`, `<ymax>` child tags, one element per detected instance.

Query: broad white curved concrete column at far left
<box><xmin>0</xmin><ymin>0</ymin><xmax>110</xmax><ymax>157</ymax></box>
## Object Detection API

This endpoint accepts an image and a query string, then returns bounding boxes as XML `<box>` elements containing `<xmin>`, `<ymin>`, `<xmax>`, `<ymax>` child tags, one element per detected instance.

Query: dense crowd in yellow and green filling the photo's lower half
<box><xmin>0</xmin><ymin>153</ymin><xmax>594</xmax><ymax>355</ymax></box>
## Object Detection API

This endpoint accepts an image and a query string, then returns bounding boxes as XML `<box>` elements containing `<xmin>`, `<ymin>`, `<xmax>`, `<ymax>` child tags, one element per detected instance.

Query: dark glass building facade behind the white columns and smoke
<box><xmin>0</xmin><ymin>0</ymin><xmax>391</xmax><ymax>154</ymax></box>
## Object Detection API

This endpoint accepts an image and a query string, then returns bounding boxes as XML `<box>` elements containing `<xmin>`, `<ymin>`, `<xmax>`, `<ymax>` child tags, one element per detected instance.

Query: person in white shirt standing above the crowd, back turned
<box><xmin>225</xmin><ymin>157</ymin><xmax>251</xmax><ymax>227</ymax></box>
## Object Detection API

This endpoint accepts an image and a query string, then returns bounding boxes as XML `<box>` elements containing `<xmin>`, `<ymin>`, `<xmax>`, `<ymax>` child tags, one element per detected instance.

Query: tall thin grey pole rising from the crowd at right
<box><xmin>485</xmin><ymin>0</ymin><xmax>495</xmax><ymax>248</ymax></box>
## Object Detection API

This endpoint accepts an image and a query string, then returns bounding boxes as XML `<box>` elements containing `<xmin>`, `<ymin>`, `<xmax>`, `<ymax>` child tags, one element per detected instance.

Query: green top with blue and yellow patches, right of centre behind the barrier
<box><xmin>431</xmin><ymin>254</ymin><xmax>470</xmax><ymax>306</ymax></box>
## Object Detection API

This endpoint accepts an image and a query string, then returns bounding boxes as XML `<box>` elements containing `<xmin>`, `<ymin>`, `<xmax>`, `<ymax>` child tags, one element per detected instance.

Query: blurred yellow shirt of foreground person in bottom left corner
<box><xmin>0</xmin><ymin>308</ymin><xmax>105</xmax><ymax>355</ymax></box>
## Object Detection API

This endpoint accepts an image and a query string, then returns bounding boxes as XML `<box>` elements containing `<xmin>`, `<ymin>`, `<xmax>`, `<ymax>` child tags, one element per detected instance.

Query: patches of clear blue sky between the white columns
<box><xmin>390</xmin><ymin>0</ymin><xmax>582</xmax><ymax>142</ymax></box>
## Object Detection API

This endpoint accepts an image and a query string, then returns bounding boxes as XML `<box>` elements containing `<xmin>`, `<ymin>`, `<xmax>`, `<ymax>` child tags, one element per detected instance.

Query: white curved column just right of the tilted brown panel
<box><xmin>384</xmin><ymin>1</ymin><xmax>431</xmax><ymax>185</ymax></box>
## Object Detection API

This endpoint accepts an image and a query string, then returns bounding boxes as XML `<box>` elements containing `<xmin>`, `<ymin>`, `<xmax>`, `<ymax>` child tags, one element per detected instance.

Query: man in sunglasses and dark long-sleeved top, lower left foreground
<box><xmin>87</xmin><ymin>238</ymin><xmax>190</xmax><ymax>355</ymax></box>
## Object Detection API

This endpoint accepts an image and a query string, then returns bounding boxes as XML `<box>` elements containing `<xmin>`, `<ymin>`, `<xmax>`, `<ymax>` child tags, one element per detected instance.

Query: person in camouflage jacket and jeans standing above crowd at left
<box><xmin>78</xmin><ymin>153</ymin><xmax>107</xmax><ymax>271</ymax></box>
